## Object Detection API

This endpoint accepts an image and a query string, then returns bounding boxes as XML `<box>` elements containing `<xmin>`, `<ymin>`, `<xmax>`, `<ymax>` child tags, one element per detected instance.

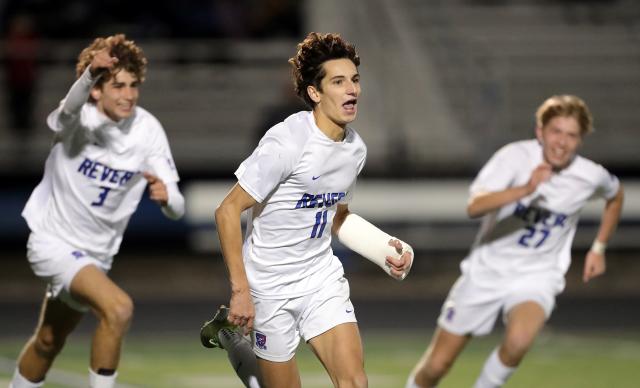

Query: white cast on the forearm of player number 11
<box><xmin>338</xmin><ymin>213</ymin><xmax>413</xmax><ymax>280</ymax></box>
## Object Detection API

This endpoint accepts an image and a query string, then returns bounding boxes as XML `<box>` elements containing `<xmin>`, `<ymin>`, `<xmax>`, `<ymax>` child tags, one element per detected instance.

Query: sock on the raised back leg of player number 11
<box><xmin>218</xmin><ymin>328</ymin><xmax>260</xmax><ymax>388</ymax></box>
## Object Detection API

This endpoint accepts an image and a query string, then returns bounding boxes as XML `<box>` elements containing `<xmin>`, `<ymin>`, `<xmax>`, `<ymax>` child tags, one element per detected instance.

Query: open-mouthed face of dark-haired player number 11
<box><xmin>309</xmin><ymin>58</ymin><xmax>360</xmax><ymax>127</ymax></box>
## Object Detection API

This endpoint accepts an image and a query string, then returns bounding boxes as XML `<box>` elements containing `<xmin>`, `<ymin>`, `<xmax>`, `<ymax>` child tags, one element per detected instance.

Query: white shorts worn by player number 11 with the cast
<box><xmin>252</xmin><ymin>278</ymin><xmax>357</xmax><ymax>362</ymax></box>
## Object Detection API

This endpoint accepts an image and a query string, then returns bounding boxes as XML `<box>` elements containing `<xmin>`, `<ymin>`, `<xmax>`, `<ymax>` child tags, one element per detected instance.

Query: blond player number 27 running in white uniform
<box><xmin>406</xmin><ymin>95</ymin><xmax>623</xmax><ymax>388</ymax></box>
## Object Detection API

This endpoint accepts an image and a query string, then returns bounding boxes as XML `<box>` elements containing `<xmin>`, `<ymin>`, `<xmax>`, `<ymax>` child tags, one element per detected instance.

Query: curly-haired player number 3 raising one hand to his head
<box><xmin>11</xmin><ymin>35</ymin><xmax>184</xmax><ymax>388</ymax></box>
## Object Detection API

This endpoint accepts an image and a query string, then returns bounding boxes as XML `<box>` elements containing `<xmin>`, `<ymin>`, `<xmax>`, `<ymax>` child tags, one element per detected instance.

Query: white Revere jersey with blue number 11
<box><xmin>235</xmin><ymin>112</ymin><xmax>366</xmax><ymax>299</ymax></box>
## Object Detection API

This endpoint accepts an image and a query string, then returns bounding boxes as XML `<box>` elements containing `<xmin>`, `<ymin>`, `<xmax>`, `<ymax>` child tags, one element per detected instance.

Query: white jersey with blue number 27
<box><xmin>462</xmin><ymin>140</ymin><xmax>619</xmax><ymax>282</ymax></box>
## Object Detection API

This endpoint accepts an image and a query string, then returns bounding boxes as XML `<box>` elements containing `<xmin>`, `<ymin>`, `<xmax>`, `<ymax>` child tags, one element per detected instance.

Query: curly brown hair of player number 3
<box><xmin>76</xmin><ymin>34</ymin><xmax>147</xmax><ymax>91</ymax></box>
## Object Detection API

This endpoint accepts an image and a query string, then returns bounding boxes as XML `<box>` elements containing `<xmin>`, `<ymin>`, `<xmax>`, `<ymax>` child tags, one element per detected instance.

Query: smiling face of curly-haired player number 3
<box><xmin>91</xmin><ymin>70</ymin><xmax>140</xmax><ymax>121</ymax></box>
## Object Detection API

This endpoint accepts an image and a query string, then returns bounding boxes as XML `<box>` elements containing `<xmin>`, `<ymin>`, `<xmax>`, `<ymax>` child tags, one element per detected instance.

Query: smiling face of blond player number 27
<box><xmin>536</xmin><ymin>116</ymin><xmax>582</xmax><ymax>170</ymax></box>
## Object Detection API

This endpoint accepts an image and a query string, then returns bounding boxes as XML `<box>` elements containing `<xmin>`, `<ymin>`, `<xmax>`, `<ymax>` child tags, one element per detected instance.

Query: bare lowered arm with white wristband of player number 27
<box><xmin>582</xmin><ymin>184</ymin><xmax>624</xmax><ymax>283</ymax></box>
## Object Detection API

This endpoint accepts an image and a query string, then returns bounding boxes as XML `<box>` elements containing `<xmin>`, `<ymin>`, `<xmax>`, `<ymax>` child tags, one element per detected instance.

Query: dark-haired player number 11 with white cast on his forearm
<box><xmin>208</xmin><ymin>33</ymin><xmax>413</xmax><ymax>387</ymax></box>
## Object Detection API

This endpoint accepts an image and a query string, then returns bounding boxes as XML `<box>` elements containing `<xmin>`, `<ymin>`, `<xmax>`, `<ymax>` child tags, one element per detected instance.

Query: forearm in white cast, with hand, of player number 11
<box><xmin>331</xmin><ymin>205</ymin><xmax>413</xmax><ymax>280</ymax></box>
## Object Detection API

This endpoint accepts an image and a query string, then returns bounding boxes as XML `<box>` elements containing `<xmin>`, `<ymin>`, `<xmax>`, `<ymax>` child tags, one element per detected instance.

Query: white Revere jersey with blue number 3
<box><xmin>22</xmin><ymin>103</ymin><xmax>179</xmax><ymax>257</ymax></box>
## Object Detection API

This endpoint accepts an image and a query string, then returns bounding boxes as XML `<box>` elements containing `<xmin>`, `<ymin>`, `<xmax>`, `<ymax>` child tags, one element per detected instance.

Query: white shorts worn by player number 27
<box><xmin>438</xmin><ymin>273</ymin><xmax>564</xmax><ymax>336</ymax></box>
